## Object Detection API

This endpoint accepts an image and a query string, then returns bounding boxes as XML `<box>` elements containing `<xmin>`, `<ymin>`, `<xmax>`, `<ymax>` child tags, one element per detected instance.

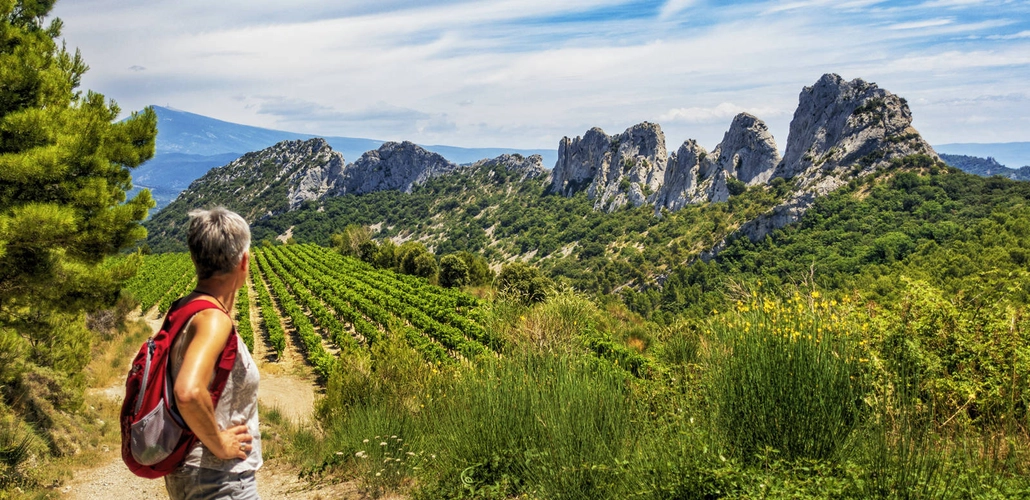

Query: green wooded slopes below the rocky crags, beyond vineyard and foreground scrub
<box><xmin>231</xmin><ymin>158</ymin><xmax>1030</xmax><ymax>323</ymax></box>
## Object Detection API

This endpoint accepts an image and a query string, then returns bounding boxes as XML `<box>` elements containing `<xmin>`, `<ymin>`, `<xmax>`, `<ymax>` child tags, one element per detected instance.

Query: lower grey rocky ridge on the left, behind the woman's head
<box><xmin>144</xmin><ymin>138</ymin><xmax>547</xmax><ymax>252</ymax></box>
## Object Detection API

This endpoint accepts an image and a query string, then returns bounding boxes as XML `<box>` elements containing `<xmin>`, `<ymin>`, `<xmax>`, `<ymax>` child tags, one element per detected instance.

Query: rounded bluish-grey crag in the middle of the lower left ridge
<box><xmin>332</xmin><ymin>141</ymin><xmax>457</xmax><ymax>195</ymax></box>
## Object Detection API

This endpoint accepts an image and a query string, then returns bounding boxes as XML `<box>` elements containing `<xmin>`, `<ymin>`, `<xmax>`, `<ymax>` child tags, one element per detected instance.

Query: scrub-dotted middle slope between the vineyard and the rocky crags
<box><xmin>252</xmin><ymin>155</ymin><xmax>789</xmax><ymax>293</ymax></box>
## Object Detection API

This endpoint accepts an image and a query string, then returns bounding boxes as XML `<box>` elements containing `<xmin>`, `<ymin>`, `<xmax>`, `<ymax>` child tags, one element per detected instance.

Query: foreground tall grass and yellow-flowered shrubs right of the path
<box><xmin>273</xmin><ymin>286</ymin><xmax>1030</xmax><ymax>500</ymax></box>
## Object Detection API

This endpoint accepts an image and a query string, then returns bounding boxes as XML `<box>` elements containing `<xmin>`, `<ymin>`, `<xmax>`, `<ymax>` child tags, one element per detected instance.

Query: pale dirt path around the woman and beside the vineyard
<box><xmin>67</xmin><ymin>294</ymin><xmax>350</xmax><ymax>500</ymax></box>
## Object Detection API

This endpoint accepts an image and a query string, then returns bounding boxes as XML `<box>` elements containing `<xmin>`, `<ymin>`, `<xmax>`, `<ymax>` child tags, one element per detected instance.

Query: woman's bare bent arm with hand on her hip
<box><xmin>174</xmin><ymin>309</ymin><xmax>253</xmax><ymax>460</ymax></box>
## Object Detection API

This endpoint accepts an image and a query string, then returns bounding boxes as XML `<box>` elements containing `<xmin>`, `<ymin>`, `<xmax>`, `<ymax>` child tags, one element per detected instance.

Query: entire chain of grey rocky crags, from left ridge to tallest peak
<box><xmin>146</xmin><ymin>74</ymin><xmax>943</xmax><ymax>258</ymax></box>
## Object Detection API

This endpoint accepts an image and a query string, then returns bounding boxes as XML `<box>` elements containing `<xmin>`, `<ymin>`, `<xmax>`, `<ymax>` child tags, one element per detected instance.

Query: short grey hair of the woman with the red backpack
<box><xmin>186</xmin><ymin>206</ymin><xmax>250</xmax><ymax>279</ymax></box>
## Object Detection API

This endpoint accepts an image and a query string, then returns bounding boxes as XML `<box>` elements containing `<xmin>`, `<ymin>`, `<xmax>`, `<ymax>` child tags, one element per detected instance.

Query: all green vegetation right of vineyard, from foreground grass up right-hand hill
<box><xmin>247</xmin><ymin>157</ymin><xmax>1030</xmax><ymax>498</ymax></box>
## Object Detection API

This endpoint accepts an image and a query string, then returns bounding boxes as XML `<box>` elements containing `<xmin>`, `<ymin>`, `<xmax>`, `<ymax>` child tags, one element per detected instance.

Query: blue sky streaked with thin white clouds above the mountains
<box><xmin>55</xmin><ymin>0</ymin><xmax>1030</xmax><ymax>149</ymax></box>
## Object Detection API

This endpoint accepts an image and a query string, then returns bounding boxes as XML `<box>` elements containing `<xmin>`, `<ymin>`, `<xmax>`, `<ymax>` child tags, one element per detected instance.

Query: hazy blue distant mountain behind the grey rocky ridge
<box><xmin>133</xmin><ymin>106</ymin><xmax>557</xmax><ymax>212</ymax></box>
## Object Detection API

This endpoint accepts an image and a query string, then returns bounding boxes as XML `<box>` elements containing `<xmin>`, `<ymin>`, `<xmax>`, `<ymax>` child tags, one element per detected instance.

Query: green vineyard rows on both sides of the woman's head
<box><xmin>126</xmin><ymin>244</ymin><xmax>492</xmax><ymax>377</ymax></box>
